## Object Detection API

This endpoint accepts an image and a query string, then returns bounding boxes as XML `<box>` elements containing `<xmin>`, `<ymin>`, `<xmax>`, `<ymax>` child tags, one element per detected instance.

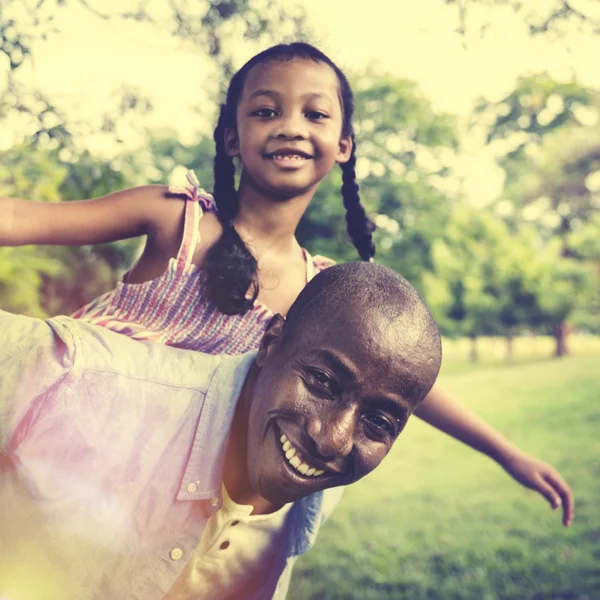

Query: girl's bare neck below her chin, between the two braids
<box><xmin>234</xmin><ymin>181</ymin><xmax>315</xmax><ymax>252</ymax></box>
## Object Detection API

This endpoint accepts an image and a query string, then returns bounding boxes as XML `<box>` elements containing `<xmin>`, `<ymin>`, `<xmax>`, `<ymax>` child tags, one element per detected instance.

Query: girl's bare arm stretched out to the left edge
<box><xmin>0</xmin><ymin>185</ymin><xmax>175</xmax><ymax>246</ymax></box>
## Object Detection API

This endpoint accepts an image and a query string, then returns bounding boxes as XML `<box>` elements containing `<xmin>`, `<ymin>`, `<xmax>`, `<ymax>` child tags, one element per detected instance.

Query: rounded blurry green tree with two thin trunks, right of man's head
<box><xmin>426</xmin><ymin>204</ymin><xmax>537</xmax><ymax>361</ymax></box>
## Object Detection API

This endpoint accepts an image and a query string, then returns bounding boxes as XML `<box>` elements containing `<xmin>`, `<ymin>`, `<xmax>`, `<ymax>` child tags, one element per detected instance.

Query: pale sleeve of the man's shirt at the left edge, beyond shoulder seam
<box><xmin>0</xmin><ymin>311</ymin><xmax>74</xmax><ymax>455</ymax></box>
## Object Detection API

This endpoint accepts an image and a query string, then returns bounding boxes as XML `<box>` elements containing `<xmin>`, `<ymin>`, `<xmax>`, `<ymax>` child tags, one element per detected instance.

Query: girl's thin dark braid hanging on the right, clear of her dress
<box><xmin>341</xmin><ymin>134</ymin><xmax>375</xmax><ymax>261</ymax></box>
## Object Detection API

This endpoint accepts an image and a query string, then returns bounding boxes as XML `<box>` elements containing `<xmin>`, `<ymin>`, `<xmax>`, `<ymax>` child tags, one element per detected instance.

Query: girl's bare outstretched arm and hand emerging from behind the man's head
<box><xmin>415</xmin><ymin>386</ymin><xmax>574</xmax><ymax>527</ymax></box>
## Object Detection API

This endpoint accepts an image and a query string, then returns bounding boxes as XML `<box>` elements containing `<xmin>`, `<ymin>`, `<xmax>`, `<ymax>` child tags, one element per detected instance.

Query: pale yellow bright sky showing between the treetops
<box><xmin>0</xmin><ymin>0</ymin><xmax>600</xmax><ymax>201</ymax></box>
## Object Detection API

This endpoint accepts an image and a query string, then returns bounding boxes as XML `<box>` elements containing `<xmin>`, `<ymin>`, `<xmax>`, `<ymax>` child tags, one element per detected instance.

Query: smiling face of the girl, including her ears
<box><xmin>225</xmin><ymin>58</ymin><xmax>352</xmax><ymax>199</ymax></box>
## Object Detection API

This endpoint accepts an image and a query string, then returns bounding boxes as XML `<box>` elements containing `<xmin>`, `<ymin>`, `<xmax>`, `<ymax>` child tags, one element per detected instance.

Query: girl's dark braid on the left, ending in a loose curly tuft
<box><xmin>202</xmin><ymin>106</ymin><xmax>258</xmax><ymax>315</ymax></box>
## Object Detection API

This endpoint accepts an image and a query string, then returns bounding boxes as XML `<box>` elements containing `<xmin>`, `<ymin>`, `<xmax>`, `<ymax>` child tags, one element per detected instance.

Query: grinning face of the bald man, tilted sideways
<box><xmin>247</xmin><ymin>311</ymin><xmax>437</xmax><ymax>504</ymax></box>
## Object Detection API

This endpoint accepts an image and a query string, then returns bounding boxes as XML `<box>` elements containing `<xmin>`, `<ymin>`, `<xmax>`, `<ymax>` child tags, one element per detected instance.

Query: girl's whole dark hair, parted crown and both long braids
<box><xmin>202</xmin><ymin>42</ymin><xmax>375</xmax><ymax>315</ymax></box>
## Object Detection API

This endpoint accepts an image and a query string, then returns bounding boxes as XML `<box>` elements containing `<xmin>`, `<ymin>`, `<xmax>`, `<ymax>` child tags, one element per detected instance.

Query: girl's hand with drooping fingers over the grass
<box><xmin>502</xmin><ymin>451</ymin><xmax>575</xmax><ymax>527</ymax></box>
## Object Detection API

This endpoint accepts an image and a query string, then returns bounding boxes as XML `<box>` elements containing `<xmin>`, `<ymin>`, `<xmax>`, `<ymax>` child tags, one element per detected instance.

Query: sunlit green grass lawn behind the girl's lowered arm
<box><xmin>288</xmin><ymin>338</ymin><xmax>600</xmax><ymax>600</ymax></box>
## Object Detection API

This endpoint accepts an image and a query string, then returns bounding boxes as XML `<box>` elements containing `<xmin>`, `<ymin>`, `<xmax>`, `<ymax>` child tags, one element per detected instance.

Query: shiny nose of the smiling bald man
<box><xmin>306</xmin><ymin>406</ymin><xmax>358</xmax><ymax>458</ymax></box>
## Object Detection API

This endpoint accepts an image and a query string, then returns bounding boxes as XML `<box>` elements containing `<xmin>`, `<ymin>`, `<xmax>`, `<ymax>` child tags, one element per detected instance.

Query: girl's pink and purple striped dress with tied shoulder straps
<box><xmin>72</xmin><ymin>172</ymin><xmax>334</xmax><ymax>354</ymax></box>
